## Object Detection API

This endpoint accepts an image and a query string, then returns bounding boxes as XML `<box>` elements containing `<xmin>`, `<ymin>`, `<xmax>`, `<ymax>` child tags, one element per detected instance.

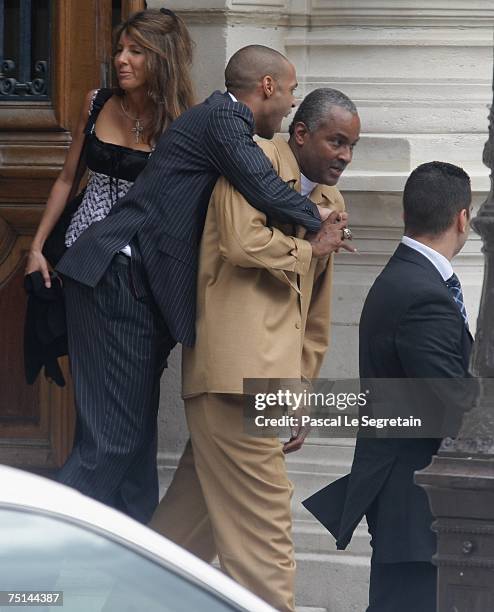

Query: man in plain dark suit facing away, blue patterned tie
<box><xmin>304</xmin><ymin>162</ymin><xmax>472</xmax><ymax>612</ymax></box>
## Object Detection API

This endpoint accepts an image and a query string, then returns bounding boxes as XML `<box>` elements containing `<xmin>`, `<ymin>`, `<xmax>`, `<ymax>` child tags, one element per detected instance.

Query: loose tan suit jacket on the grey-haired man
<box><xmin>182</xmin><ymin>137</ymin><xmax>345</xmax><ymax>397</ymax></box>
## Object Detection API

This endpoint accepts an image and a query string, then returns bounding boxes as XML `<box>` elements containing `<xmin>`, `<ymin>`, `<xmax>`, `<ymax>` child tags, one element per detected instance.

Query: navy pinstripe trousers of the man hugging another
<box><xmin>58</xmin><ymin>254</ymin><xmax>175</xmax><ymax>523</ymax></box>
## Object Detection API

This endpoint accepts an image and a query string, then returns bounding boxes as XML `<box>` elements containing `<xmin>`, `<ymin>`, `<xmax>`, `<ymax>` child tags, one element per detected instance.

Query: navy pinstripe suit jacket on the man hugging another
<box><xmin>57</xmin><ymin>91</ymin><xmax>320</xmax><ymax>345</ymax></box>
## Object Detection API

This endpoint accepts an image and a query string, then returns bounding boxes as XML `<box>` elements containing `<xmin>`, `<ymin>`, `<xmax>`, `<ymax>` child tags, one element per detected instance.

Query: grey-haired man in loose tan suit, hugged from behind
<box><xmin>151</xmin><ymin>89</ymin><xmax>360</xmax><ymax>612</ymax></box>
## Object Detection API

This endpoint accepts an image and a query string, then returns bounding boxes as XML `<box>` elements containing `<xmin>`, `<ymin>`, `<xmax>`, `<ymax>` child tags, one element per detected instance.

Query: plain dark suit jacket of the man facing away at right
<box><xmin>304</xmin><ymin>244</ymin><xmax>473</xmax><ymax>563</ymax></box>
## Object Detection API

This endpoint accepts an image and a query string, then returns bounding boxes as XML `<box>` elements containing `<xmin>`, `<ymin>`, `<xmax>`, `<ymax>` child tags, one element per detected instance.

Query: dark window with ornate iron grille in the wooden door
<box><xmin>0</xmin><ymin>0</ymin><xmax>52</xmax><ymax>100</ymax></box>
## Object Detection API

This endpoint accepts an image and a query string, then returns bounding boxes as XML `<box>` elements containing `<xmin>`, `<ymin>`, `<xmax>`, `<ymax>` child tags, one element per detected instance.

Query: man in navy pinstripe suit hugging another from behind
<box><xmin>57</xmin><ymin>45</ymin><xmax>352</xmax><ymax>521</ymax></box>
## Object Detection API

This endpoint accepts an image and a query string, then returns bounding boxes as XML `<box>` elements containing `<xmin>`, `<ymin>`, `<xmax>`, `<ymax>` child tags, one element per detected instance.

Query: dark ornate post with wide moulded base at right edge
<box><xmin>416</xmin><ymin>49</ymin><xmax>494</xmax><ymax>612</ymax></box>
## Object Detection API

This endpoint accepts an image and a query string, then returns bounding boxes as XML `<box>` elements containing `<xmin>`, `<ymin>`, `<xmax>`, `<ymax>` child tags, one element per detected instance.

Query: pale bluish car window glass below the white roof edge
<box><xmin>0</xmin><ymin>509</ymin><xmax>239</xmax><ymax>612</ymax></box>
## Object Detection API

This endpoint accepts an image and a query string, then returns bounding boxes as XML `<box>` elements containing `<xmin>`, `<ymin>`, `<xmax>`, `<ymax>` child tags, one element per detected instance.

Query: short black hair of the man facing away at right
<box><xmin>403</xmin><ymin>161</ymin><xmax>472</xmax><ymax>236</ymax></box>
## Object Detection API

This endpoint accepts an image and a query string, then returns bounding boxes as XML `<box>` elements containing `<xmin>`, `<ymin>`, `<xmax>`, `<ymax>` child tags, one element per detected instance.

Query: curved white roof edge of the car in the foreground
<box><xmin>0</xmin><ymin>465</ymin><xmax>276</xmax><ymax>612</ymax></box>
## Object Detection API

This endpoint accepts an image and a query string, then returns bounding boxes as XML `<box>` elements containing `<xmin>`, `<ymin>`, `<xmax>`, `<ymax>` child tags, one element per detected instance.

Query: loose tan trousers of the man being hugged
<box><xmin>150</xmin><ymin>394</ymin><xmax>295</xmax><ymax>612</ymax></box>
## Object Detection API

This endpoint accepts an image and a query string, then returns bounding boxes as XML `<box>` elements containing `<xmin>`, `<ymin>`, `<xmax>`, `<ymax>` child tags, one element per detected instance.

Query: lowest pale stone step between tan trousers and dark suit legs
<box><xmin>295</xmin><ymin>553</ymin><xmax>369</xmax><ymax>612</ymax></box>
